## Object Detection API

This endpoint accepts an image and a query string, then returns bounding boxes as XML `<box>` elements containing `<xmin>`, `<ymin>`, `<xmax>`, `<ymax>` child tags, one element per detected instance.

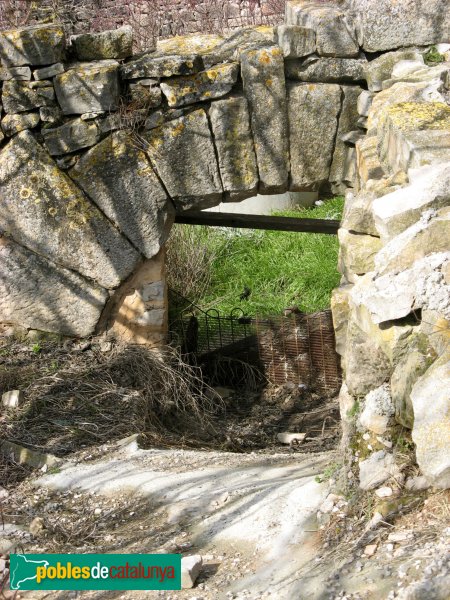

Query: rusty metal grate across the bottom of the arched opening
<box><xmin>170</xmin><ymin>294</ymin><xmax>342</xmax><ymax>395</ymax></box>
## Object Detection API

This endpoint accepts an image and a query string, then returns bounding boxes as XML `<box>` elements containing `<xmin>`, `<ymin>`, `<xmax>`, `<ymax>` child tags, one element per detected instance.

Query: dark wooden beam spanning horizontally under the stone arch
<box><xmin>175</xmin><ymin>211</ymin><xmax>340</xmax><ymax>235</ymax></box>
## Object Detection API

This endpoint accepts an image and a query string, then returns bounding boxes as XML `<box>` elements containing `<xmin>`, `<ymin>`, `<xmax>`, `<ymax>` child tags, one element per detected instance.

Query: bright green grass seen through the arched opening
<box><xmin>173</xmin><ymin>197</ymin><xmax>344</xmax><ymax>315</ymax></box>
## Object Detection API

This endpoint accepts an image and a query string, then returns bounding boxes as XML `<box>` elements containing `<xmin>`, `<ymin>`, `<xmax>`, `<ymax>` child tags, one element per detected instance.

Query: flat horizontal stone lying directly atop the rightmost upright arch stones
<box><xmin>285</xmin><ymin>55</ymin><xmax>367</xmax><ymax>84</ymax></box>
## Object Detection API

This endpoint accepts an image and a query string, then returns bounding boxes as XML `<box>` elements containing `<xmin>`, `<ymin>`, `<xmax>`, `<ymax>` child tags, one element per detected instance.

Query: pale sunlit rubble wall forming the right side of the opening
<box><xmin>332</xmin><ymin>45</ymin><xmax>450</xmax><ymax>490</ymax></box>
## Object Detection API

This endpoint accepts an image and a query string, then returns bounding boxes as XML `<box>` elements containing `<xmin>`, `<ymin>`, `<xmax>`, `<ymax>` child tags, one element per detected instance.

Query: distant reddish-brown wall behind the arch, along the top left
<box><xmin>0</xmin><ymin>0</ymin><xmax>285</xmax><ymax>47</ymax></box>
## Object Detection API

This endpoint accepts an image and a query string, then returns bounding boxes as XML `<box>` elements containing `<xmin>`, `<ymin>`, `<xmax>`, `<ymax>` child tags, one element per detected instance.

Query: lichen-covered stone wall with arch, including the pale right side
<box><xmin>0</xmin><ymin>0</ymin><xmax>450</xmax><ymax>489</ymax></box>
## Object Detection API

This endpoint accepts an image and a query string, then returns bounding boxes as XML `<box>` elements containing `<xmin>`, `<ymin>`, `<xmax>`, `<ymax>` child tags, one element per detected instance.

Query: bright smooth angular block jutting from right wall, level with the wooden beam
<box><xmin>372</xmin><ymin>164</ymin><xmax>450</xmax><ymax>243</ymax></box>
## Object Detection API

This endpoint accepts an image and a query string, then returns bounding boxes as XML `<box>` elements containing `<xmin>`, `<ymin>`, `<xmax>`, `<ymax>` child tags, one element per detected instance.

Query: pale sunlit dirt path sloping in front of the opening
<box><xmin>22</xmin><ymin>444</ymin><xmax>333</xmax><ymax>600</ymax></box>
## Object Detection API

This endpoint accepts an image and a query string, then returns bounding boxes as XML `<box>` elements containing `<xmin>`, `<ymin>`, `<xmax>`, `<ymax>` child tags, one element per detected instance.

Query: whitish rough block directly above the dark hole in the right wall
<box><xmin>351</xmin><ymin>252</ymin><xmax>450</xmax><ymax>323</ymax></box>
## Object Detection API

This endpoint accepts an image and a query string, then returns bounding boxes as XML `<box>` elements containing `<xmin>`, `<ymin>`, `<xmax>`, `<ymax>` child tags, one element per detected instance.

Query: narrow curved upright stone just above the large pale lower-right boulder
<box><xmin>391</xmin><ymin>334</ymin><xmax>436</xmax><ymax>429</ymax></box>
